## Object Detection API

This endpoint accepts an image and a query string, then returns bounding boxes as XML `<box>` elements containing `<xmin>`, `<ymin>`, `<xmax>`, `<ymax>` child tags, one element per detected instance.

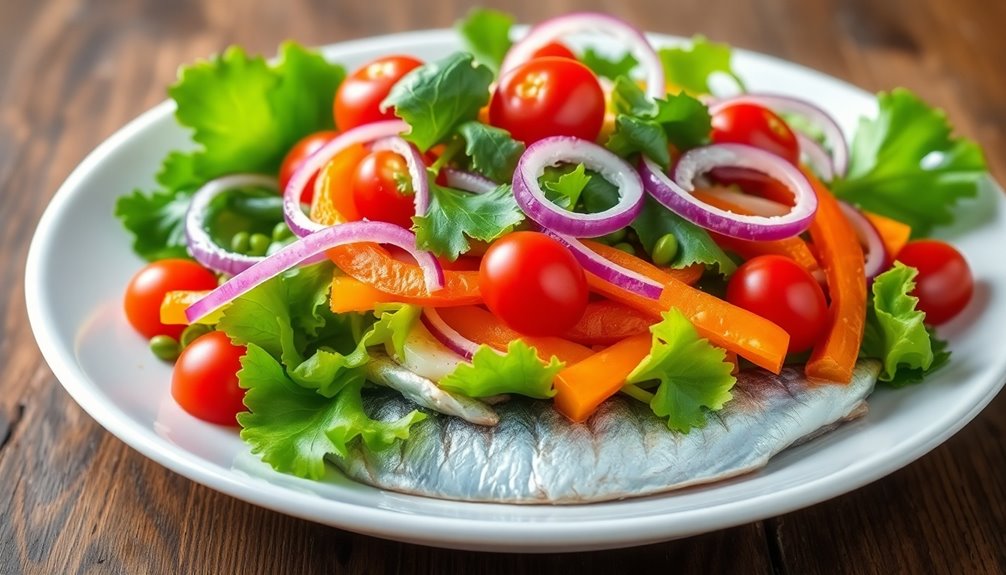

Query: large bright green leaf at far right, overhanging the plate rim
<box><xmin>833</xmin><ymin>88</ymin><xmax>986</xmax><ymax>236</ymax></box>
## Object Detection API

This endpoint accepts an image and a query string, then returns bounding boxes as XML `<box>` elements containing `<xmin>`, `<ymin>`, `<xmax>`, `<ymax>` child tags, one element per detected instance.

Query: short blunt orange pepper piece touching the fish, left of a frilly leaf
<box><xmin>554</xmin><ymin>334</ymin><xmax>653</xmax><ymax>422</ymax></box>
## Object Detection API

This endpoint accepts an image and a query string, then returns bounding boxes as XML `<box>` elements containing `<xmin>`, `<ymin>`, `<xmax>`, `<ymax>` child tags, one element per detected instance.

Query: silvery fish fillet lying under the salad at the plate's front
<box><xmin>334</xmin><ymin>361</ymin><xmax>880</xmax><ymax>504</ymax></box>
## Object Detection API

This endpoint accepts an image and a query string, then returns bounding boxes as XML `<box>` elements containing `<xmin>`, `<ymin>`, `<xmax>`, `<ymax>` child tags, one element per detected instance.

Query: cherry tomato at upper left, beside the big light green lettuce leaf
<box><xmin>332</xmin><ymin>56</ymin><xmax>423</xmax><ymax>131</ymax></box>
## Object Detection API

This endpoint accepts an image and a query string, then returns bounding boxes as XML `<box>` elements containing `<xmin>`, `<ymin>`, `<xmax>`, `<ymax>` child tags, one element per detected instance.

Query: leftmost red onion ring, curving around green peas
<box><xmin>185</xmin><ymin>174</ymin><xmax>279</xmax><ymax>275</ymax></box>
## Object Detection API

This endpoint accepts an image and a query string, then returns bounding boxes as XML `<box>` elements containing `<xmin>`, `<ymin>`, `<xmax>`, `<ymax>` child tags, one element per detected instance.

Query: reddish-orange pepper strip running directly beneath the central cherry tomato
<box><xmin>437</xmin><ymin>306</ymin><xmax>594</xmax><ymax>364</ymax></box>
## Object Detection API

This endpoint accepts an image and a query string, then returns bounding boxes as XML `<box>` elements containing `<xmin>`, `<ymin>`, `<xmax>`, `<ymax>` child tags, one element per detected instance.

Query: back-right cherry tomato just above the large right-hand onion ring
<box><xmin>711</xmin><ymin>104</ymin><xmax>800</xmax><ymax>165</ymax></box>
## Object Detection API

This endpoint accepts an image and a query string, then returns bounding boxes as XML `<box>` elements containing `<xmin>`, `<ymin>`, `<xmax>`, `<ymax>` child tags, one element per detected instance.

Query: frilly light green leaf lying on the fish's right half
<box><xmin>627</xmin><ymin>309</ymin><xmax>736</xmax><ymax>433</ymax></box>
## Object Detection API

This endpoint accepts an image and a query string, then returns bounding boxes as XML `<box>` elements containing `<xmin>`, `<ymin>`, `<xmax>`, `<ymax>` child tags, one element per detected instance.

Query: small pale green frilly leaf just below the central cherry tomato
<box><xmin>439</xmin><ymin>340</ymin><xmax>564</xmax><ymax>399</ymax></box>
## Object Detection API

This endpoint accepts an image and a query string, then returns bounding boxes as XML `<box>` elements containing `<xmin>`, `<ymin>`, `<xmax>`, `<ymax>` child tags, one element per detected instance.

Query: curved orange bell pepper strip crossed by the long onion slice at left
<box><xmin>311</xmin><ymin>147</ymin><xmax>482</xmax><ymax>307</ymax></box>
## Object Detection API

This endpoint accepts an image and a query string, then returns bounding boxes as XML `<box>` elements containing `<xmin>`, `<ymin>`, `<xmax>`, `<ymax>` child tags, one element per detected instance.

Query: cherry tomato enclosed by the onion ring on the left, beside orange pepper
<box><xmin>353</xmin><ymin>150</ymin><xmax>415</xmax><ymax>229</ymax></box>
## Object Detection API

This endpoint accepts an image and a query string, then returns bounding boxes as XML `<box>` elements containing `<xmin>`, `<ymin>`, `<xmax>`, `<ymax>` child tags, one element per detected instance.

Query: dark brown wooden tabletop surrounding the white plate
<box><xmin>0</xmin><ymin>0</ymin><xmax>1006</xmax><ymax>574</ymax></box>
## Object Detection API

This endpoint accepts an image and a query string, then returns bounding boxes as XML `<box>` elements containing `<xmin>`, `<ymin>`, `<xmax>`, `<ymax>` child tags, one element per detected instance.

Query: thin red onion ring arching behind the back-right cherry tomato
<box><xmin>709</xmin><ymin>93</ymin><xmax>849</xmax><ymax>179</ymax></box>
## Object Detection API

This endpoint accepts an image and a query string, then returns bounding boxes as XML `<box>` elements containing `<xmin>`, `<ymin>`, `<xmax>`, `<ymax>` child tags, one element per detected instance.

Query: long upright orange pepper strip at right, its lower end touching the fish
<box><xmin>803</xmin><ymin>169</ymin><xmax>866</xmax><ymax>383</ymax></box>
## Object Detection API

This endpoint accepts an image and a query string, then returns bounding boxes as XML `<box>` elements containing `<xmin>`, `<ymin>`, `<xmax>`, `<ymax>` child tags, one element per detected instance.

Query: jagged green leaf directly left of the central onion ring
<box><xmin>412</xmin><ymin>182</ymin><xmax>524</xmax><ymax>261</ymax></box>
